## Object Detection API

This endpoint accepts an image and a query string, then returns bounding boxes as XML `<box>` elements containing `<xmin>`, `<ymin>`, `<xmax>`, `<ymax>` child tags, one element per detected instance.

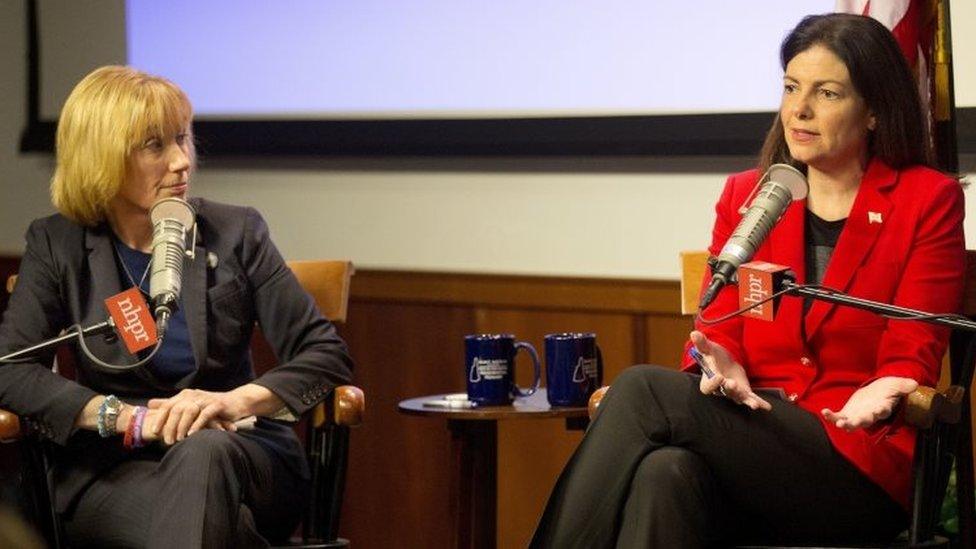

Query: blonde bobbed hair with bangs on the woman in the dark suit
<box><xmin>51</xmin><ymin>65</ymin><xmax>196</xmax><ymax>226</ymax></box>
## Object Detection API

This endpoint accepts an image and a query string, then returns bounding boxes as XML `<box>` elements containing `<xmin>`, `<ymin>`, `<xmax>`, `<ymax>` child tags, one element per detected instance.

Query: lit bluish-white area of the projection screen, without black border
<box><xmin>126</xmin><ymin>0</ymin><xmax>833</xmax><ymax>119</ymax></box>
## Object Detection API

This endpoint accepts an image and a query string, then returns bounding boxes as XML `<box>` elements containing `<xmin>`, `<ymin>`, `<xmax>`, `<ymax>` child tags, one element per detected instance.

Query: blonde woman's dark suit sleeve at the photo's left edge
<box><xmin>0</xmin><ymin>220</ymin><xmax>97</xmax><ymax>445</ymax></box>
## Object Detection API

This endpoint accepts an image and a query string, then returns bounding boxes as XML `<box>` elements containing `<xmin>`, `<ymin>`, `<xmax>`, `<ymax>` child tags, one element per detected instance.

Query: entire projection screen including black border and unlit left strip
<box><xmin>21</xmin><ymin>0</ymin><xmax>968</xmax><ymax>155</ymax></box>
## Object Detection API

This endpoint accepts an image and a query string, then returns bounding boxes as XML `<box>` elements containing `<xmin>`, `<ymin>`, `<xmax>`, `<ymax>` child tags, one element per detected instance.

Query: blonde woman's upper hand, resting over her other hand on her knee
<box><xmin>143</xmin><ymin>389</ymin><xmax>250</xmax><ymax>444</ymax></box>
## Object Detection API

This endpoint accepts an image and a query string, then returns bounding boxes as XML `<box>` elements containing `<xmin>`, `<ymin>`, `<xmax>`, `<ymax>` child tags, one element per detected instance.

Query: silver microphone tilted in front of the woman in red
<box><xmin>698</xmin><ymin>164</ymin><xmax>807</xmax><ymax>311</ymax></box>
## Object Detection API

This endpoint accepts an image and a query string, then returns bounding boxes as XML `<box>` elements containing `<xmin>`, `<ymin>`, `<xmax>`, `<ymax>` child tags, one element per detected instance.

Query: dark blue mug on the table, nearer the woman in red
<box><xmin>546</xmin><ymin>333</ymin><xmax>603</xmax><ymax>406</ymax></box>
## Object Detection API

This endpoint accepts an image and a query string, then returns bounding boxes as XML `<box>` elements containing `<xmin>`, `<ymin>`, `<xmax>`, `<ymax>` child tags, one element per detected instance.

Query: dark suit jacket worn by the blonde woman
<box><xmin>0</xmin><ymin>199</ymin><xmax>352</xmax><ymax>510</ymax></box>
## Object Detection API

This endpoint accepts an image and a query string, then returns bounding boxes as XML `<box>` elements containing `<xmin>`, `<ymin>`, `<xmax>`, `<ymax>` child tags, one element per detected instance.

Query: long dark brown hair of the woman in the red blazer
<box><xmin>759</xmin><ymin>13</ymin><xmax>933</xmax><ymax>172</ymax></box>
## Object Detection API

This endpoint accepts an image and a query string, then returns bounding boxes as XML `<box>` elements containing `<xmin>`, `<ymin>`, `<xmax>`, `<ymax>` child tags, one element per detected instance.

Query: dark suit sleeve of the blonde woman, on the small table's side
<box><xmin>241</xmin><ymin>208</ymin><xmax>352</xmax><ymax>415</ymax></box>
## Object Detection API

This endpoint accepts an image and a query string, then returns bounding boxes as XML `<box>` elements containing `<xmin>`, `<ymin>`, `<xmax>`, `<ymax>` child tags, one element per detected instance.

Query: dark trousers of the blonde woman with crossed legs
<box><xmin>63</xmin><ymin>430</ymin><xmax>309</xmax><ymax>549</ymax></box>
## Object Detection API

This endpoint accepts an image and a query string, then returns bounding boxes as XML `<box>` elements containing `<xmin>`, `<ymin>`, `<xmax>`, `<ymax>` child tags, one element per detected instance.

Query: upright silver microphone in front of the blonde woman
<box><xmin>149</xmin><ymin>197</ymin><xmax>196</xmax><ymax>336</ymax></box>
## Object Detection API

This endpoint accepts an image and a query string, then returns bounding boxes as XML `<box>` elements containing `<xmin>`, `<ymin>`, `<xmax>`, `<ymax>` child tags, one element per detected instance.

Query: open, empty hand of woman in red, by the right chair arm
<box><xmin>820</xmin><ymin>377</ymin><xmax>918</xmax><ymax>431</ymax></box>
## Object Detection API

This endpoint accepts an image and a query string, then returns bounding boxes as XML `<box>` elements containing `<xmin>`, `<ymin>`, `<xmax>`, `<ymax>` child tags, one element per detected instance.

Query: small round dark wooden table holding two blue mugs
<box><xmin>398</xmin><ymin>389</ymin><xmax>589</xmax><ymax>549</ymax></box>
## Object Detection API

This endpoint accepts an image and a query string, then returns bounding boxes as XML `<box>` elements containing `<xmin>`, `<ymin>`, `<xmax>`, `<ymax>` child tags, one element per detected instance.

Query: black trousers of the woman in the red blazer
<box><xmin>531</xmin><ymin>366</ymin><xmax>907</xmax><ymax>549</ymax></box>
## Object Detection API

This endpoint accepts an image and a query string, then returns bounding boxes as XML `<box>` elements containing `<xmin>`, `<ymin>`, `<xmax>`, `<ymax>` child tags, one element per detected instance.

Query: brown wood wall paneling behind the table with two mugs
<box><xmin>340</xmin><ymin>270</ymin><xmax>691</xmax><ymax>548</ymax></box>
